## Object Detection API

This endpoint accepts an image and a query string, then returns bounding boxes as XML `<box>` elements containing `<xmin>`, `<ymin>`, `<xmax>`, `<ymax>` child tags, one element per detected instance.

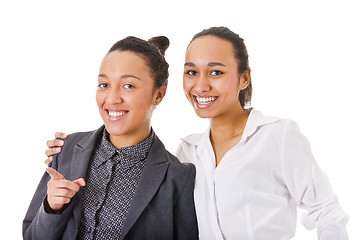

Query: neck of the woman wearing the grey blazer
<box><xmin>109</xmin><ymin>126</ymin><xmax>151</xmax><ymax>148</ymax></box>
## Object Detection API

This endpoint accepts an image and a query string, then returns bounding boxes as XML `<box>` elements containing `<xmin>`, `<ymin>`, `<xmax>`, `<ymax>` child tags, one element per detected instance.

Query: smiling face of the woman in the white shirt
<box><xmin>183</xmin><ymin>36</ymin><xmax>248</xmax><ymax>118</ymax></box>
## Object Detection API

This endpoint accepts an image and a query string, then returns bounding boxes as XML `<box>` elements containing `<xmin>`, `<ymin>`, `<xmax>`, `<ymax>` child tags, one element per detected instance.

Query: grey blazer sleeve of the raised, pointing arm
<box><xmin>23</xmin><ymin>149</ymin><xmax>72</xmax><ymax>240</ymax></box>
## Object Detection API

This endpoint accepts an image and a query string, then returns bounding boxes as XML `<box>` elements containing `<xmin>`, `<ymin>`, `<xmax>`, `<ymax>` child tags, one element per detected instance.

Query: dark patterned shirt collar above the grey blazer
<box><xmin>95</xmin><ymin>128</ymin><xmax>155</xmax><ymax>167</ymax></box>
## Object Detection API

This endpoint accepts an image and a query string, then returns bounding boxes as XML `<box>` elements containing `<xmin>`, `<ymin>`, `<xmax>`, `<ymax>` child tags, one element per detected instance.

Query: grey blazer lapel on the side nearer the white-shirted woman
<box><xmin>121</xmin><ymin>135</ymin><xmax>169</xmax><ymax>239</ymax></box>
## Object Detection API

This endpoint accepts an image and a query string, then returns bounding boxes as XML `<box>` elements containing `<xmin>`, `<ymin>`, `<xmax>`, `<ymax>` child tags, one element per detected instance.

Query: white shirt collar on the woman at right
<box><xmin>181</xmin><ymin>108</ymin><xmax>279</xmax><ymax>145</ymax></box>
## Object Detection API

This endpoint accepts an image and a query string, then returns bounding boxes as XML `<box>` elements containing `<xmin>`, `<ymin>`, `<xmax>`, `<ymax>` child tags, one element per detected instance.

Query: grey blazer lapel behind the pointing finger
<box><xmin>70</xmin><ymin>126</ymin><xmax>104</xmax><ymax>233</ymax></box>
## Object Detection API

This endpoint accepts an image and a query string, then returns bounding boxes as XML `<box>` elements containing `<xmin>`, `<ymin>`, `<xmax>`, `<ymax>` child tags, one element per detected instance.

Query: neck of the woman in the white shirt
<box><xmin>210</xmin><ymin>107</ymin><xmax>249</xmax><ymax>142</ymax></box>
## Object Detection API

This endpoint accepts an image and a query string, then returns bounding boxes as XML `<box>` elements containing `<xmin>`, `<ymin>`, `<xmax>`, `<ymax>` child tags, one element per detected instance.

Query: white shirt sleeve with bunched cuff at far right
<box><xmin>282</xmin><ymin>121</ymin><xmax>348</xmax><ymax>240</ymax></box>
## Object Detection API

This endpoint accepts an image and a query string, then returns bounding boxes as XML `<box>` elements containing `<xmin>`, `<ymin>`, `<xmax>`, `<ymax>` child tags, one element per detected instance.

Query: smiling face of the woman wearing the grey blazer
<box><xmin>96</xmin><ymin>51</ymin><xmax>166</xmax><ymax>141</ymax></box>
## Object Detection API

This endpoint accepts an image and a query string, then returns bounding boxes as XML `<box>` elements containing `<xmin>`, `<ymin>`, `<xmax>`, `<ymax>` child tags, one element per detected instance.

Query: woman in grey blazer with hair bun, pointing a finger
<box><xmin>23</xmin><ymin>37</ymin><xmax>198</xmax><ymax>240</ymax></box>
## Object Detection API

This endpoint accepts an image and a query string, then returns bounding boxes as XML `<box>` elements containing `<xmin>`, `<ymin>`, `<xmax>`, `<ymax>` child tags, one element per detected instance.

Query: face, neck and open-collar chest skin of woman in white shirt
<box><xmin>183</xmin><ymin>36</ymin><xmax>250</xmax><ymax>166</ymax></box>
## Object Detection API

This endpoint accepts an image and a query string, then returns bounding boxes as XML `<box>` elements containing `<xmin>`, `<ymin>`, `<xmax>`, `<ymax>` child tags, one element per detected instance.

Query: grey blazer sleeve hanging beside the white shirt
<box><xmin>174</xmin><ymin>163</ymin><xmax>198</xmax><ymax>239</ymax></box>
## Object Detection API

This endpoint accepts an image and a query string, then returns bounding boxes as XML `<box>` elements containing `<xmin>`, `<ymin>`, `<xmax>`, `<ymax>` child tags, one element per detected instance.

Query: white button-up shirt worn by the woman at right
<box><xmin>176</xmin><ymin>109</ymin><xmax>348</xmax><ymax>240</ymax></box>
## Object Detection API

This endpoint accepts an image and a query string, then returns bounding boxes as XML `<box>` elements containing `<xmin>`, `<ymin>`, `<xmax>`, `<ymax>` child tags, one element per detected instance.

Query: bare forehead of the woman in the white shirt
<box><xmin>186</xmin><ymin>36</ymin><xmax>235</xmax><ymax>61</ymax></box>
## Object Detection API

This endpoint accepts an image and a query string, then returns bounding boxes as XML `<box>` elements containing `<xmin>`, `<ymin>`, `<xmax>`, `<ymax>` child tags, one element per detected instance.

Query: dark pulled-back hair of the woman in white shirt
<box><xmin>190</xmin><ymin>27</ymin><xmax>253</xmax><ymax>108</ymax></box>
